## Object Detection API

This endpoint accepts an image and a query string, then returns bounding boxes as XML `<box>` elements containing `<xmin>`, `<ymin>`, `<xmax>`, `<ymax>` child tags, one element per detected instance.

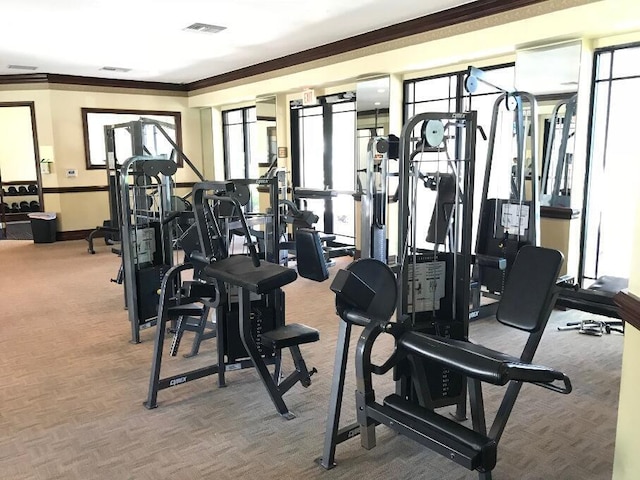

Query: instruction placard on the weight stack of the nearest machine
<box><xmin>407</xmin><ymin>261</ymin><xmax>446</xmax><ymax>313</ymax></box>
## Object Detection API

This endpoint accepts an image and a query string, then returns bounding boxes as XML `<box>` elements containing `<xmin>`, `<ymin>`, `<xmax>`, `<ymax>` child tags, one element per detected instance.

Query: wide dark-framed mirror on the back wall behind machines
<box><xmin>82</xmin><ymin>108</ymin><xmax>182</xmax><ymax>170</ymax></box>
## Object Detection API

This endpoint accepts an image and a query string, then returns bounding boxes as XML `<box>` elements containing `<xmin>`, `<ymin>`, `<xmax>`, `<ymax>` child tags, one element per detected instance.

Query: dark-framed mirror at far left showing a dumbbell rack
<box><xmin>0</xmin><ymin>102</ymin><xmax>42</xmax><ymax>222</ymax></box>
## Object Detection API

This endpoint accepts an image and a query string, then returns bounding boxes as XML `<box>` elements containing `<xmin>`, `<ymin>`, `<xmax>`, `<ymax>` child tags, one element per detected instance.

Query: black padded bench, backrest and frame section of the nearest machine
<box><xmin>356</xmin><ymin>245</ymin><xmax>572</xmax><ymax>480</ymax></box>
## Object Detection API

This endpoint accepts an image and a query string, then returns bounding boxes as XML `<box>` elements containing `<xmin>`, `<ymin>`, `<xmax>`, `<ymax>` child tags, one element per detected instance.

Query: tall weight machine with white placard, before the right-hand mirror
<box><xmin>465</xmin><ymin>67</ymin><xmax>540</xmax><ymax>318</ymax></box>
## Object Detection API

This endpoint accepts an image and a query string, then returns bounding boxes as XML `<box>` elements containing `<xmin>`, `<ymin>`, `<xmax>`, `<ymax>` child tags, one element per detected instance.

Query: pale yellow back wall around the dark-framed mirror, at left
<box><xmin>0</xmin><ymin>85</ymin><xmax>205</xmax><ymax>231</ymax></box>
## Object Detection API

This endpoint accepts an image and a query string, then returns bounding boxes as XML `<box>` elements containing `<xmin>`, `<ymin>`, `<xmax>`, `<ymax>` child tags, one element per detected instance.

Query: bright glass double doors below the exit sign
<box><xmin>291</xmin><ymin>96</ymin><xmax>356</xmax><ymax>244</ymax></box>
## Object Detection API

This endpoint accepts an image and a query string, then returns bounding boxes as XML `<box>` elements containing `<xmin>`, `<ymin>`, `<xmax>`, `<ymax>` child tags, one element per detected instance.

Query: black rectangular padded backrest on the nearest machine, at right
<box><xmin>496</xmin><ymin>245</ymin><xmax>564</xmax><ymax>332</ymax></box>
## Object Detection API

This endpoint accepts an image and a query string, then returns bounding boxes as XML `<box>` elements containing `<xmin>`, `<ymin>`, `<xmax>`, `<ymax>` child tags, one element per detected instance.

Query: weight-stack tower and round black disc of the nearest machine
<box><xmin>319</xmin><ymin>112</ymin><xmax>476</xmax><ymax>469</ymax></box>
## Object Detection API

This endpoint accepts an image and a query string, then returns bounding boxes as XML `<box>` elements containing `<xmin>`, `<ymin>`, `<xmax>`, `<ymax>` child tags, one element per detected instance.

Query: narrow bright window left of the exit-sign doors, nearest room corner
<box><xmin>222</xmin><ymin>107</ymin><xmax>259</xmax><ymax>179</ymax></box>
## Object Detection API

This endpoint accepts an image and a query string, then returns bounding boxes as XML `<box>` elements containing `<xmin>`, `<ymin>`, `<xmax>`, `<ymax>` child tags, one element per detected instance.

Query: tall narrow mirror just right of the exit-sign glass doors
<box><xmin>355</xmin><ymin>77</ymin><xmax>397</xmax><ymax>262</ymax></box>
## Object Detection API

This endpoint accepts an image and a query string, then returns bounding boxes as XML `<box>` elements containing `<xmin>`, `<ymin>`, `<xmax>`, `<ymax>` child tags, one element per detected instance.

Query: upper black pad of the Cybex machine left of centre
<box><xmin>204</xmin><ymin>255</ymin><xmax>298</xmax><ymax>294</ymax></box>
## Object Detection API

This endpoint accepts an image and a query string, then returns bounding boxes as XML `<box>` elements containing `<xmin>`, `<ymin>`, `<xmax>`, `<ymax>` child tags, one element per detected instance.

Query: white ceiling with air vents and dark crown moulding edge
<box><xmin>0</xmin><ymin>0</ymin><xmax>470</xmax><ymax>83</ymax></box>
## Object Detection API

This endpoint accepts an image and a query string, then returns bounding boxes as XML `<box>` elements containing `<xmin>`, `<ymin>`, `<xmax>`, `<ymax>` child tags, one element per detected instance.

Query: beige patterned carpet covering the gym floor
<box><xmin>0</xmin><ymin>241</ymin><xmax>622</xmax><ymax>480</ymax></box>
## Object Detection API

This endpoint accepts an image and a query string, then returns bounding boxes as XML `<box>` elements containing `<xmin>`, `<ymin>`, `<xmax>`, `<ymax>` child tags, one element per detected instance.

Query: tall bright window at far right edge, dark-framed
<box><xmin>580</xmin><ymin>45</ymin><xmax>640</xmax><ymax>279</ymax></box>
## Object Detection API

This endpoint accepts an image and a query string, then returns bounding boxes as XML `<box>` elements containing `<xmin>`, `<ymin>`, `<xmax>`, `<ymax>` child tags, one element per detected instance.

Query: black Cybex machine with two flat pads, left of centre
<box><xmin>144</xmin><ymin>182</ymin><xmax>328</xmax><ymax>419</ymax></box>
